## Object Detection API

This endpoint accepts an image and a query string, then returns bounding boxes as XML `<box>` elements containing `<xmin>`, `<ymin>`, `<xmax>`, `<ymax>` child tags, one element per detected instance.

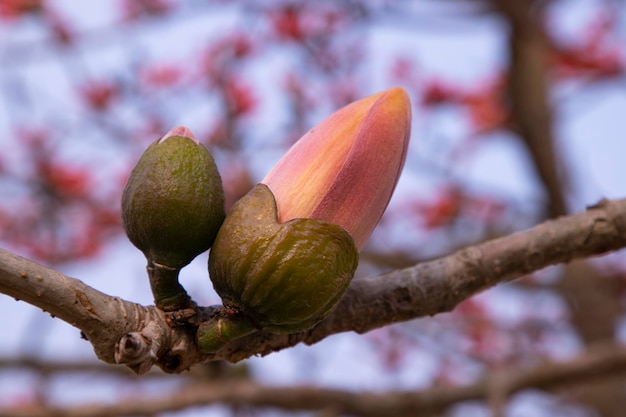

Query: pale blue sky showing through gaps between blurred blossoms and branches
<box><xmin>0</xmin><ymin>0</ymin><xmax>626</xmax><ymax>416</ymax></box>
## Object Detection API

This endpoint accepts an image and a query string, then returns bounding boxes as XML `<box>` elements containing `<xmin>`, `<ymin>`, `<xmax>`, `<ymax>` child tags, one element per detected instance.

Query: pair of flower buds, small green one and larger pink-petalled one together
<box><xmin>122</xmin><ymin>88</ymin><xmax>411</xmax><ymax>352</ymax></box>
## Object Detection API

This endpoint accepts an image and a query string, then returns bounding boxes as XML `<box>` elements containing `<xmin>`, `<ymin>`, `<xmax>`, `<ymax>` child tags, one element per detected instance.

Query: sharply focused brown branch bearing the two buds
<box><xmin>0</xmin><ymin>199</ymin><xmax>626</xmax><ymax>372</ymax></box>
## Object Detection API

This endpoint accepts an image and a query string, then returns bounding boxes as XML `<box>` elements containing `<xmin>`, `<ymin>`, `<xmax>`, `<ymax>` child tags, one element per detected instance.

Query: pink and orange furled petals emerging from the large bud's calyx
<box><xmin>261</xmin><ymin>87</ymin><xmax>411</xmax><ymax>248</ymax></box>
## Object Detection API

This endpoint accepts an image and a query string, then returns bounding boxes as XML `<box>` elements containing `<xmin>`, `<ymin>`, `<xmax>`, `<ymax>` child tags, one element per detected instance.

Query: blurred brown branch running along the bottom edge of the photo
<box><xmin>0</xmin><ymin>344</ymin><xmax>626</xmax><ymax>417</ymax></box>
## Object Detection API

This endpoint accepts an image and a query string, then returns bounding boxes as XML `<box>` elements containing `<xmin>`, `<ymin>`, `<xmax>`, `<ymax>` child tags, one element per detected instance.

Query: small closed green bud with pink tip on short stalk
<box><xmin>122</xmin><ymin>127</ymin><xmax>225</xmax><ymax>309</ymax></box>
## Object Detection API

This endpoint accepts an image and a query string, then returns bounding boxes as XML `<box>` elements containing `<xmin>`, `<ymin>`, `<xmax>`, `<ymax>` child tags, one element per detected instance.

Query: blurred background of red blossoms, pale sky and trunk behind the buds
<box><xmin>0</xmin><ymin>0</ymin><xmax>626</xmax><ymax>416</ymax></box>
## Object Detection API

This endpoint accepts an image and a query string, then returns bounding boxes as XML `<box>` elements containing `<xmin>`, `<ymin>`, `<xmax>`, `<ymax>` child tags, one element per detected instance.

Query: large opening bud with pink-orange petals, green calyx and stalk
<box><xmin>197</xmin><ymin>88</ymin><xmax>411</xmax><ymax>352</ymax></box>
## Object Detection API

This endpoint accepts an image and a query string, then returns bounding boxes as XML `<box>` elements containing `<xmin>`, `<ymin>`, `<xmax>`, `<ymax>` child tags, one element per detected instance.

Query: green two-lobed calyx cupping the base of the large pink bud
<box><xmin>198</xmin><ymin>184</ymin><xmax>358</xmax><ymax>352</ymax></box>
